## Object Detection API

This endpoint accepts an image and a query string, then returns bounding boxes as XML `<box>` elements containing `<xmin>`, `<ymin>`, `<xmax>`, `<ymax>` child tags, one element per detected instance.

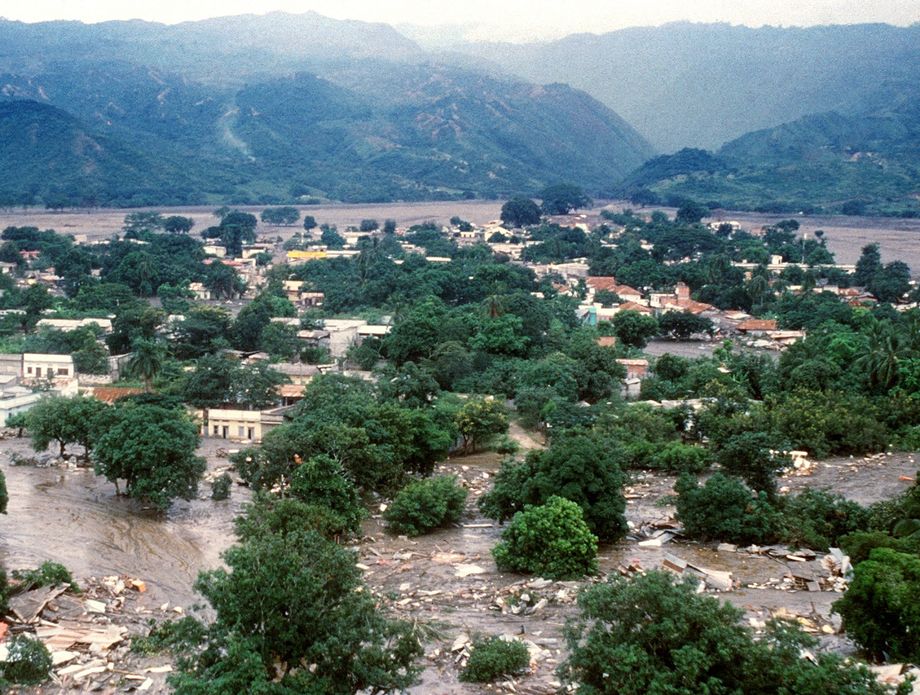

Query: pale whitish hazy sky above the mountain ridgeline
<box><xmin>0</xmin><ymin>0</ymin><xmax>920</xmax><ymax>40</ymax></box>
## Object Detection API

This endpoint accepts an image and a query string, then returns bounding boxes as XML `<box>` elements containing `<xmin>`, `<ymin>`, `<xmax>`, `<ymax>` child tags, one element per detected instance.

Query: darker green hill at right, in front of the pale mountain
<box><xmin>618</xmin><ymin>95</ymin><xmax>920</xmax><ymax>216</ymax></box>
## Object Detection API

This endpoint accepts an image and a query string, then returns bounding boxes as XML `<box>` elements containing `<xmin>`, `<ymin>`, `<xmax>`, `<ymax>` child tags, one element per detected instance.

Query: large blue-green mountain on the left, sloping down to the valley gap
<box><xmin>0</xmin><ymin>13</ymin><xmax>654</xmax><ymax>205</ymax></box>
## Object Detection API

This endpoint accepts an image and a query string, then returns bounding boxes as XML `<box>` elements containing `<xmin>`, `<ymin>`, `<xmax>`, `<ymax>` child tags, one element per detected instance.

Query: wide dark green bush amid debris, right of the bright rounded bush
<box><xmin>675</xmin><ymin>473</ymin><xmax>782</xmax><ymax>543</ymax></box>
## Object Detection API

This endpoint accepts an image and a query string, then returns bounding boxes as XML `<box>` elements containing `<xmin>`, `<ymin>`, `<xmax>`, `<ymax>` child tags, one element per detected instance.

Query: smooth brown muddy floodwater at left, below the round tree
<box><xmin>0</xmin><ymin>439</ymin><xmax>249</xmax><ymax>605</ymax></box>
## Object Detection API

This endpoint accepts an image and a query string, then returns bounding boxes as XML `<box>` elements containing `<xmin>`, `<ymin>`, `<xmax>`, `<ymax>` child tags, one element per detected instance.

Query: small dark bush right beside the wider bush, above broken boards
<box><xmin>783</xmin><ymin>490</ymin><xmax>868</xmax><ymax>551</ymax></box>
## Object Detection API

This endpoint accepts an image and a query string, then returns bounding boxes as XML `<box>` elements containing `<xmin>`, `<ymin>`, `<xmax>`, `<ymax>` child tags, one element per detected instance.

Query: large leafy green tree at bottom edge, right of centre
<box><xmin>560</xmin><ymin>571</ymin><xmax>910</xmax><ymax>695</ymax></box>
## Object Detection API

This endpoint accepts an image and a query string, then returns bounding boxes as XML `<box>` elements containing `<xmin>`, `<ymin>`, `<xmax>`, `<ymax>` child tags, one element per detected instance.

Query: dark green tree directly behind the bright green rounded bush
<box><xmin>479</xmin><ymin>430</ymin><xmax>626</xmax><ymax>540</ymax></box>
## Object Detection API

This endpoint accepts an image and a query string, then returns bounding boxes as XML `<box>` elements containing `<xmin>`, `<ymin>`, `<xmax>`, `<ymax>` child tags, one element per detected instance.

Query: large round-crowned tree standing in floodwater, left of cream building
<box><xmin>93</xmin><ymin>403</ymin><xmax>206</xmax><ymax>511</ymax></box>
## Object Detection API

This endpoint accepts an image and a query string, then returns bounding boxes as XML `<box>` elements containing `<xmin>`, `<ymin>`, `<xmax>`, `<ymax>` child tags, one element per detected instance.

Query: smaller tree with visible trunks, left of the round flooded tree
<box><xmin>26</xmin><ymin>396</ymin><xmax>108</xmax><ymax>458</ymax></box>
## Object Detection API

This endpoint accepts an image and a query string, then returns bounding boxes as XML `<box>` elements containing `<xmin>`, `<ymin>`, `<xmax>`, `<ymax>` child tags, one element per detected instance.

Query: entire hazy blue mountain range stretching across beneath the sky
<box><xmin>0</xmin><ymin>13</ymin><xmax>920</xmax><ymax>212</ymax></box>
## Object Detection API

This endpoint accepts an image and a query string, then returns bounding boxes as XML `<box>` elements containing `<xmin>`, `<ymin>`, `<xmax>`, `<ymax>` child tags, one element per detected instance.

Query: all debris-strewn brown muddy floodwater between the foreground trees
<box><xmin>0</xmin><ymin>436</ymin><xmax>917</xmax><ymax>694</ymax></box>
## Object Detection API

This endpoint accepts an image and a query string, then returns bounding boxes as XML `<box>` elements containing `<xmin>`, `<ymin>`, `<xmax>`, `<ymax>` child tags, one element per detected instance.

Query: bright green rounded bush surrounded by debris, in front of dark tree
<box><xmin>492</xmin><ymin>496</ymin><xmax>597</xmax><ymax>579</ymax></box>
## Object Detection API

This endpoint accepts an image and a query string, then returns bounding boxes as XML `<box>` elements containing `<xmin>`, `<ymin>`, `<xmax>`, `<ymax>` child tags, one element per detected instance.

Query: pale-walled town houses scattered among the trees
<box><xmin>0</xmin><ymin>209</ymin><xmax>912</xmax><ymax>442</ymax></box>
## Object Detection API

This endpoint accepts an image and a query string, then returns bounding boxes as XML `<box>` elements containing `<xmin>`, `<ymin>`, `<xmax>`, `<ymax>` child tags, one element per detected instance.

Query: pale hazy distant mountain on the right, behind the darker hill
<box><xmin>446</xmin><ymin>23</ymin><xmax>920</xmax><ymax>152</ymax></box>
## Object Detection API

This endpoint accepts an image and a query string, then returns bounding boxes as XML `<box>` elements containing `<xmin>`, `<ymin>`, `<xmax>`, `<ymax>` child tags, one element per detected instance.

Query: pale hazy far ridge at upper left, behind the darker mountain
<box><xmin>0</xmin><ymin>12</ymin><xmax>422</xmax><ymax>84</ymax></box>
